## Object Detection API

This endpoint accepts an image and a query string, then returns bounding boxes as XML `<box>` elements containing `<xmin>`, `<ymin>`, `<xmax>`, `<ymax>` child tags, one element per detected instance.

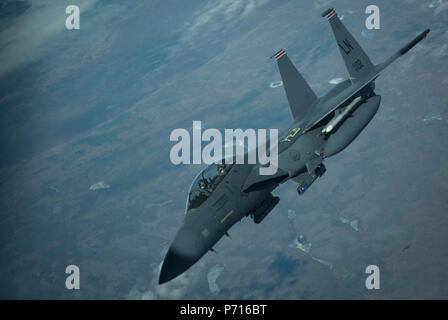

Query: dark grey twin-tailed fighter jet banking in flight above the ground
<box><xmin>159</xmin><ymin>8</ymin><xmax>429</xmax><ymax>284</ymax></box>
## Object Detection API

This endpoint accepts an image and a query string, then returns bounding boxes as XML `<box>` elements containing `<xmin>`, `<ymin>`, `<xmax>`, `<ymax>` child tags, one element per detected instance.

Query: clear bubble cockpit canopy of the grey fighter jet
<box><xmin>187</xmin><ymin>163</ymin><xmax>233</xmax><ymax>212</ymax></box>
